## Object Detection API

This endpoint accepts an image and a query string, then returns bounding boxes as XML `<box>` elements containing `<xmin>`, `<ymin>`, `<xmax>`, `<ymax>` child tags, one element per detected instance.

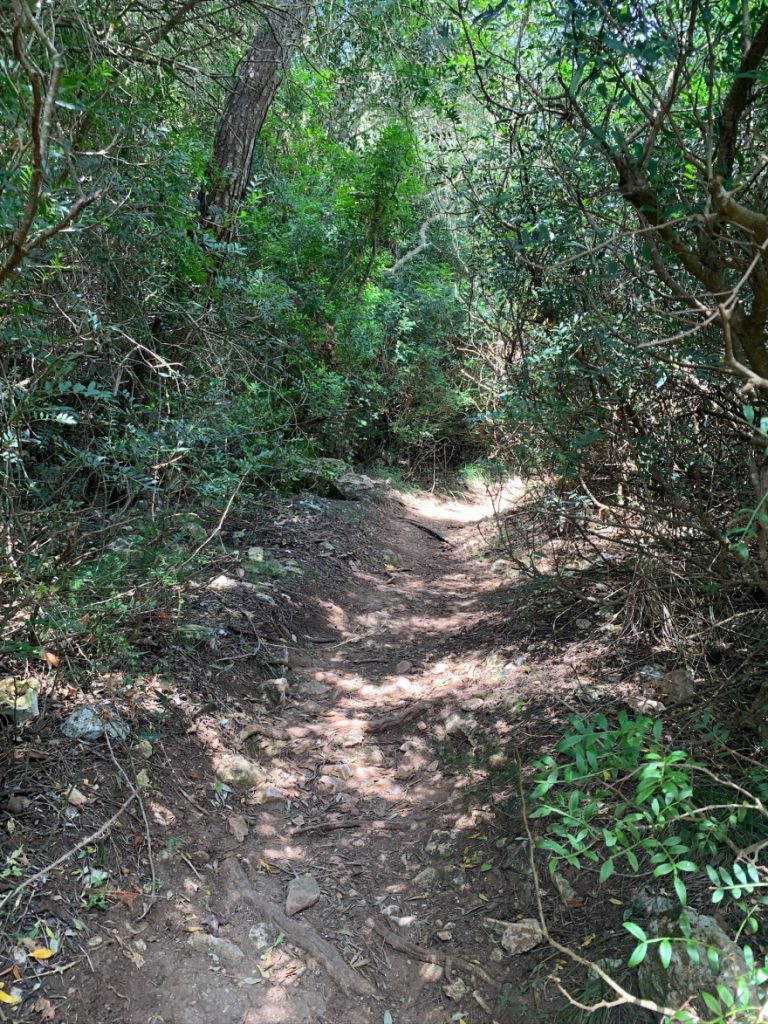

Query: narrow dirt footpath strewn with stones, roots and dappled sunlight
<box><xmin>35</xmin><ymin>489</ymin><xmax>606</xmax><ymax>1024</ymax></box>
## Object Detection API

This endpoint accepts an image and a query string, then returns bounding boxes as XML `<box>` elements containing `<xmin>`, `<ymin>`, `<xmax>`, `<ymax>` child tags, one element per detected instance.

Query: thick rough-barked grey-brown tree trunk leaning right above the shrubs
<box><xmin>200</xmin><ymin>0</ymin><xmax>312</xmax><ymax>242</ymax></box>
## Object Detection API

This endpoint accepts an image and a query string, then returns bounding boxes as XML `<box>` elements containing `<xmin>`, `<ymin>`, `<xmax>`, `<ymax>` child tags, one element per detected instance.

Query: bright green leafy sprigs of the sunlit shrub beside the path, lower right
<box><xmin>529</xmin><ymin>712</ymin><xmax>768</xmax><ymax>1020</ymax></box>
